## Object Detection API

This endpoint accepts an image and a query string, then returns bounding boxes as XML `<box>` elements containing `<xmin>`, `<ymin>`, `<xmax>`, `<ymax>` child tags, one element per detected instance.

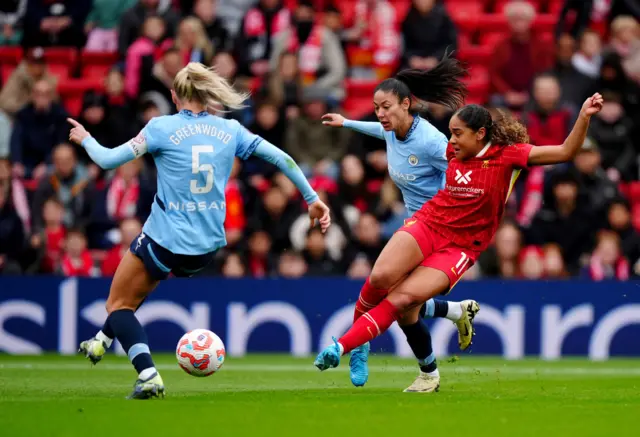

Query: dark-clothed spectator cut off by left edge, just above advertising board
<box><xmin>0</xmin><ymin>170</ymin><xmax>25</xmax><ymax>275</ymax></box>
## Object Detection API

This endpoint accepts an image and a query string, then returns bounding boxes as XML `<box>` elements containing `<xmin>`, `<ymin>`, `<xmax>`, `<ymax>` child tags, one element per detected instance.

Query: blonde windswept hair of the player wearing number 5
<box><xmin>173</xmin><ymin>62</ymin><xmax>249</xmax><ymax>109</ymax></box>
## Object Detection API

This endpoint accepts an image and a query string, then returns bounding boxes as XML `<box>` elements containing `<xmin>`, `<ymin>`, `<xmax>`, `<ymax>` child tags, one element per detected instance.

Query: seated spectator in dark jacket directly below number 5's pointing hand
<box><xmin>33</xmin><ymin>143</ymin><xmax>93</xmax><ymax>230</ymax></box>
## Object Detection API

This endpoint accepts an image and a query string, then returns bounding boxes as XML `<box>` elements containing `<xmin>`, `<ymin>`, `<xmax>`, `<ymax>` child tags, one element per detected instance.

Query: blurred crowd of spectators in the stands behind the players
<box><xmin>0</xmin><ymin>0</ymin><xmax>640</xmax><ymax>280</ymax></box>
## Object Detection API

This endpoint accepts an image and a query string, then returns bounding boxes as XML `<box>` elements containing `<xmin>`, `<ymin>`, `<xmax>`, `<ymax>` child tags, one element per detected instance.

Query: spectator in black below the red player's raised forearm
<box><xmin>528</xmin><ymin>172</ymin><xmax>599</xmax><ymax>273</ymax></box>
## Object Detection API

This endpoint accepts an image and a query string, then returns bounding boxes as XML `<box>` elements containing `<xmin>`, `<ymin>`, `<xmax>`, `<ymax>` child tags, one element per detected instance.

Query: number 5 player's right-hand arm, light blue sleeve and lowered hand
<box><xmin>253</xmin><ymin>139</ymin><xmax>331</xmax><ymax>232</ymax></box>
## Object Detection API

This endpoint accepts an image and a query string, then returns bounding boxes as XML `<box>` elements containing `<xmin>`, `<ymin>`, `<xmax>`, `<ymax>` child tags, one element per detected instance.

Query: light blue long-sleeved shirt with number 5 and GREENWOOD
<box><xmin>82</xmin><ymin>110</ymin><xmax>318</xmax><ymax>255</ymax></box>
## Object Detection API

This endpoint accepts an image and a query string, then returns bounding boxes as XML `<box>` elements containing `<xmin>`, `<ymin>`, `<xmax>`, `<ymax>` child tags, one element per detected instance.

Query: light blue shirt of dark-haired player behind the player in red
<box><xmin>343</xmin><ymin>115</ymin><xmax>448</xmax><ymax>215</ymax></box>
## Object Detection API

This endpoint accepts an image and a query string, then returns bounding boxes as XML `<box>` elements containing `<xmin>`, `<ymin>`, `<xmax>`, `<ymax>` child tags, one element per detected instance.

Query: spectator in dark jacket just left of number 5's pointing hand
<box><xmin>11</xmin><ymin>79</ymin><xmax>69</xmax><ymax>179</ymax></box>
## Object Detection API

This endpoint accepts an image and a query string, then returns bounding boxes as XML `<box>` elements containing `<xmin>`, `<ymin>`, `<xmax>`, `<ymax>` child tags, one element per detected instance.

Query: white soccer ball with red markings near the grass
<box><xmin>176</xmin><ymin>329</ymin><xmax>226</xmax><ymax>376</ymax></box>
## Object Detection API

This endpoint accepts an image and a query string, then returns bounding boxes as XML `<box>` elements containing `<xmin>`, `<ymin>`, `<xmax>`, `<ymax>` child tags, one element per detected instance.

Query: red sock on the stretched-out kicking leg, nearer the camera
<box><xmin>338</xmin><ymin>299</ymin><xmax>400</xmax><ymax>354</ymax></box>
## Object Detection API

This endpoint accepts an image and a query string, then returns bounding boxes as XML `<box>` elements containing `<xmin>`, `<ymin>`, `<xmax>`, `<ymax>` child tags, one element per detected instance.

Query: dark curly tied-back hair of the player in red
<box><xmin>456</xmin><ymin>105</ymin><xmax>529</xmax><ymax>146</ymax></box>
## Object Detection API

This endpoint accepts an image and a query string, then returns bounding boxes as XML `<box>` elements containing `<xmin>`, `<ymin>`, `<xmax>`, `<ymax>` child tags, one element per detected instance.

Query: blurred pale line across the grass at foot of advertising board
<box><xmin>0</xmin><ymin>361</ymin><xmax>640</xmax><ymax>376</ymax></box>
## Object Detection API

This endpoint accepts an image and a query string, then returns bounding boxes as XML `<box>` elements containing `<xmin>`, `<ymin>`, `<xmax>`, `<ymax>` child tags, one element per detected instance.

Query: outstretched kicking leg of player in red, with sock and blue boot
<box><xmin>314</xmin><ymin>266</ymin><xmax>450</xmax><ymax>370</ymax></box>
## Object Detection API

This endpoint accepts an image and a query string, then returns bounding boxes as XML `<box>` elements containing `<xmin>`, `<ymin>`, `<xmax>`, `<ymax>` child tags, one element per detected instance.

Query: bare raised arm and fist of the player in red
<box><xmin>529</xmin><ymin>93</ymin><xmax>604</xmax><ymax>165</ymax></box>
